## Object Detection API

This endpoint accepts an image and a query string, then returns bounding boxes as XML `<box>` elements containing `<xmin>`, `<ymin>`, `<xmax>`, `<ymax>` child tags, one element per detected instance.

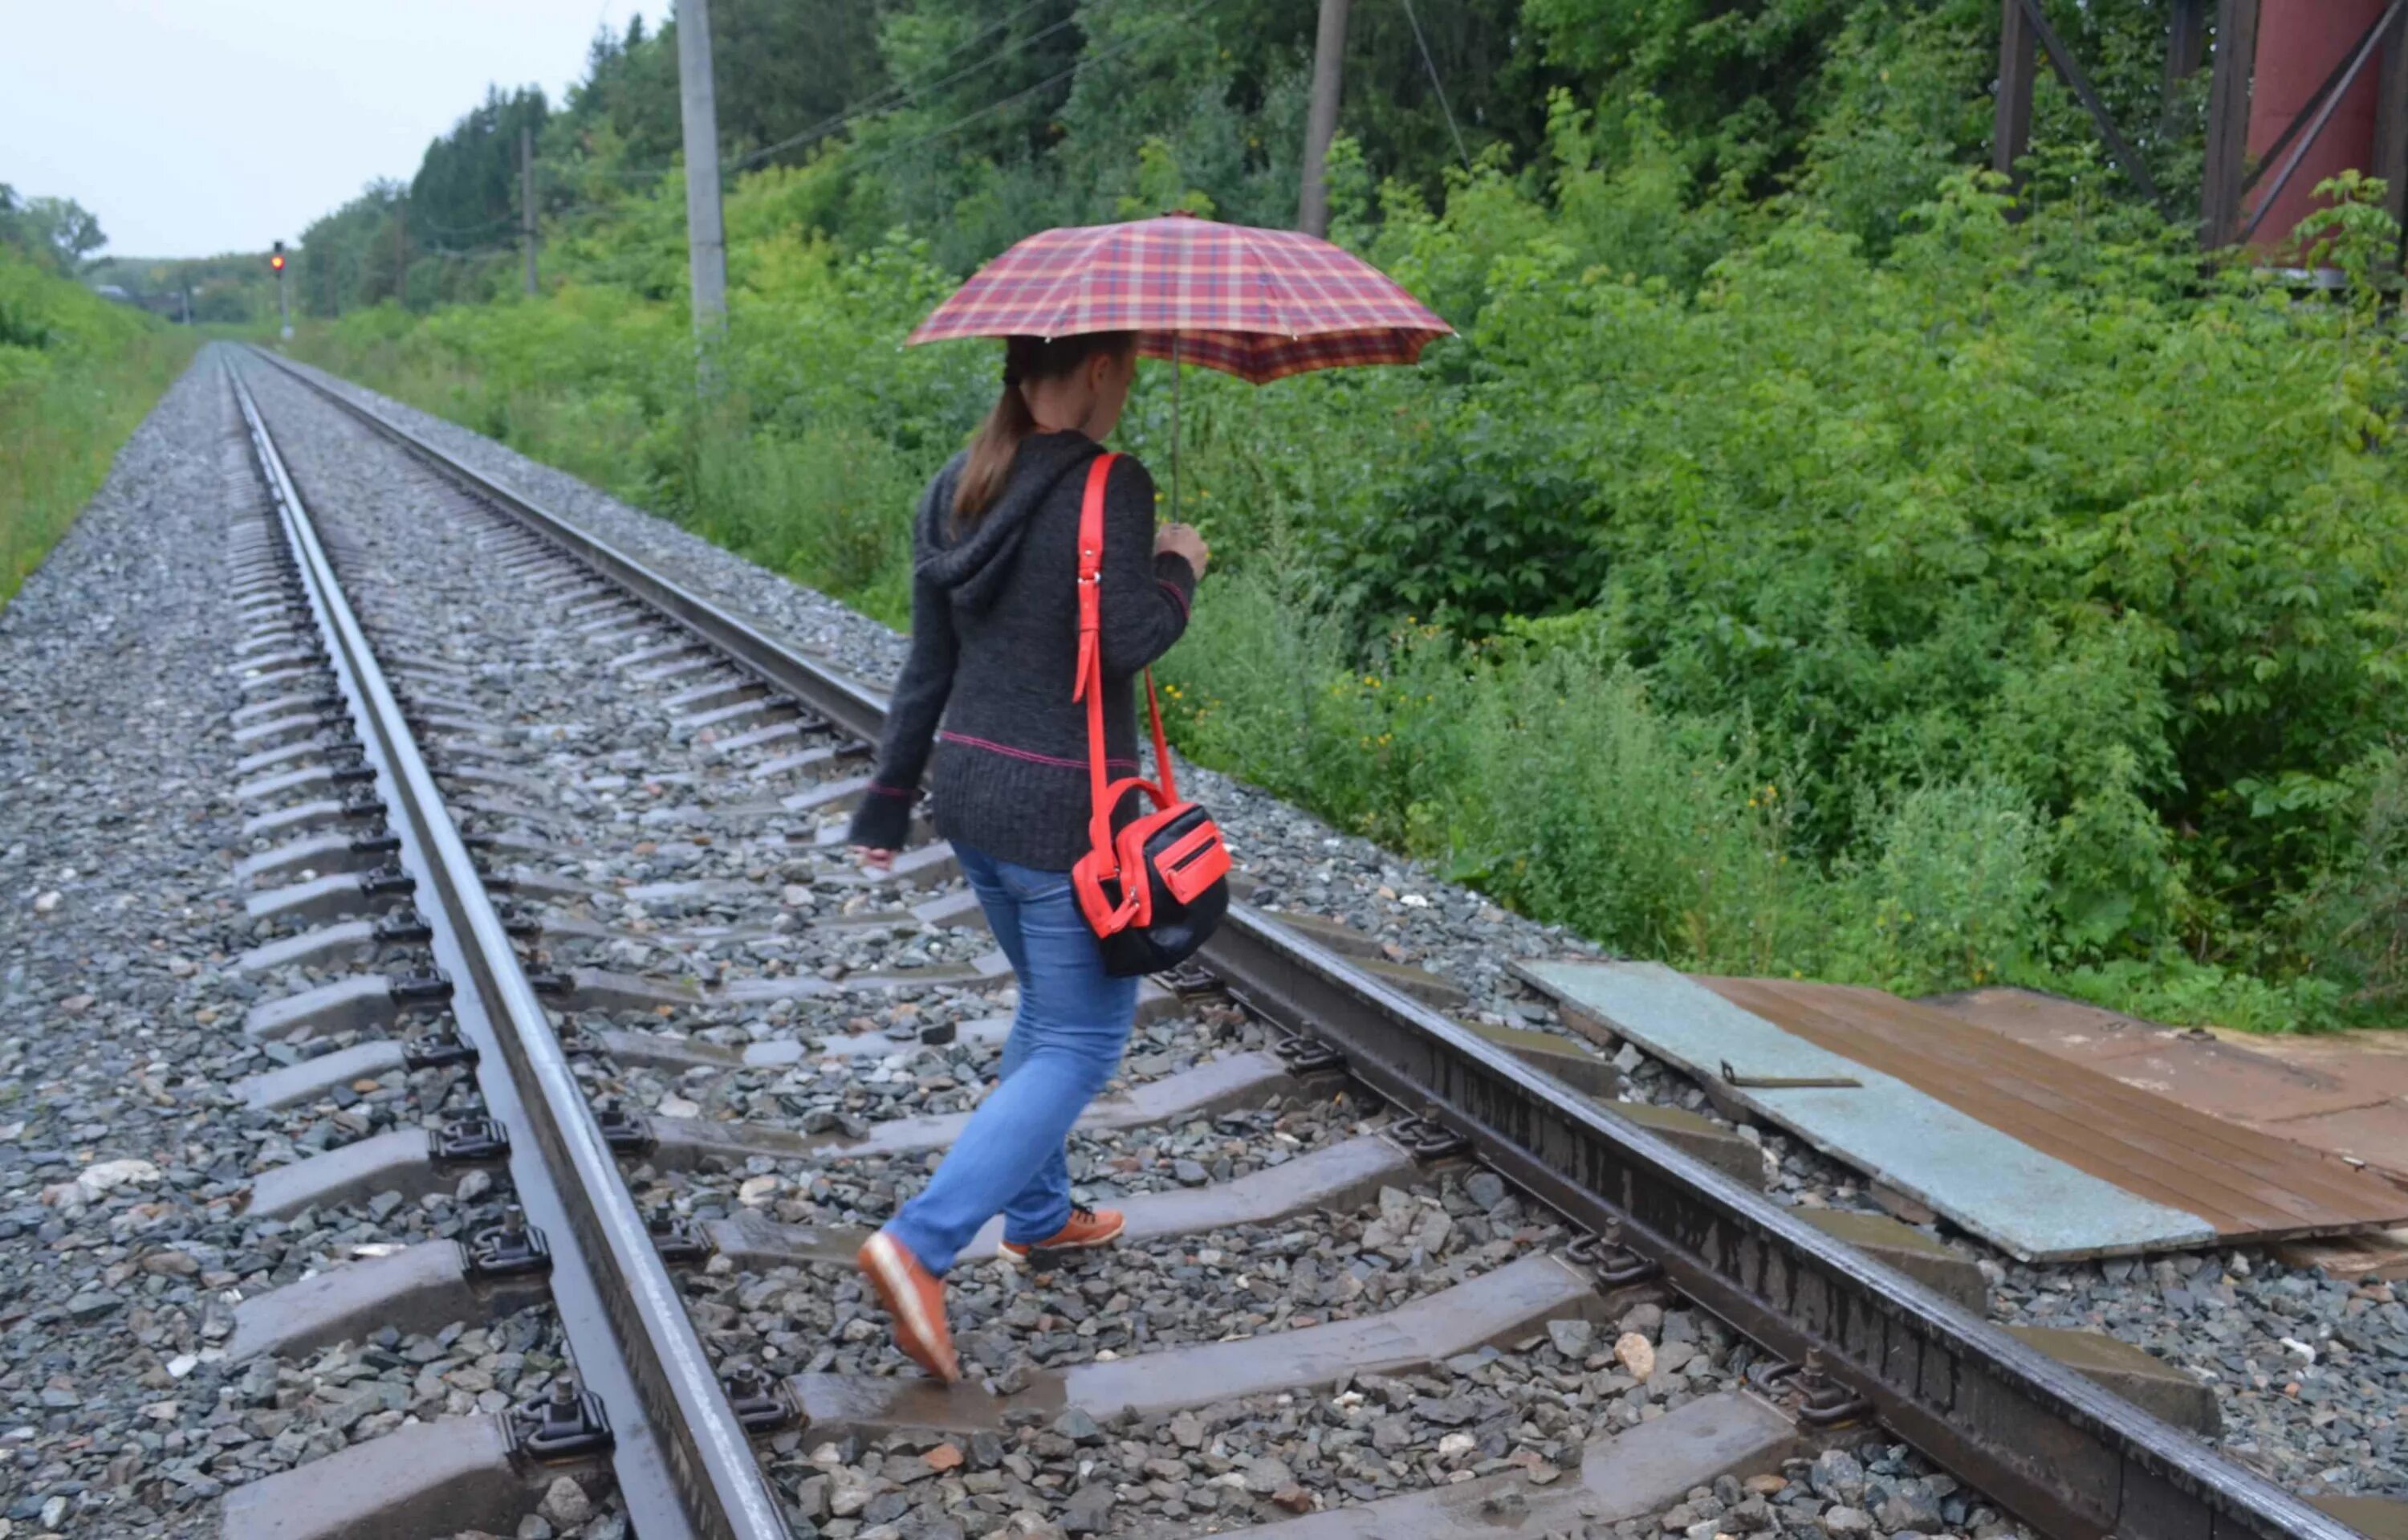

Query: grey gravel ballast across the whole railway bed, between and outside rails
<box><xmin>0</xmin><ymin>349</ymin><xmax>2408</xmax><ymax>1540</ymax></box>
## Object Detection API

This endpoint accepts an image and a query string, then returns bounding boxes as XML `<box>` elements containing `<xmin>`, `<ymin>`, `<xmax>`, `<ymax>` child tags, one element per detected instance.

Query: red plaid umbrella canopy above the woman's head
<box><xmin>908</xmin><ymin>214</ymin><xmax>1454</xmax><ymax>385</ymax></box>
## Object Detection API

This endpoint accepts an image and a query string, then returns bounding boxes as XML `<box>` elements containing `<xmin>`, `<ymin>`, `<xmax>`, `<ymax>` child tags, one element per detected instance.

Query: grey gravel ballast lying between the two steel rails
<box><xmin>239</xmin><ymin>352</ymin><xmax>1811</xmax><ymax>1535</ymax></box>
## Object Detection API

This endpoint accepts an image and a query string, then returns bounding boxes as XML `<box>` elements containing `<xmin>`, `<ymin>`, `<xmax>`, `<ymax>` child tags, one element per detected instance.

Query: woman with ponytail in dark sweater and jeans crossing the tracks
<box><xmin>852</xmin><ymin>332</ymin><xmax>1209</xmax><ymax>1381</ymax></box>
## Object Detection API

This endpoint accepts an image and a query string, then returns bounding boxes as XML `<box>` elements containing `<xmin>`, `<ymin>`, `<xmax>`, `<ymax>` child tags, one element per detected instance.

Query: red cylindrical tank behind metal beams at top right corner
<box><xmin>2244</xmin><ymin>0</ymin><xmax>2386</xmax><ymax>246</ymax></box>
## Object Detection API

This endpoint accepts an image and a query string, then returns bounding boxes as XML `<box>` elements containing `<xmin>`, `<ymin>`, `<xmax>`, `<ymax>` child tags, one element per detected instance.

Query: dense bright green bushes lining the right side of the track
<box><xmin>287</xmin><ymin>132</ymin><xmax>2408</xmax><ymax>1025</ymax></box>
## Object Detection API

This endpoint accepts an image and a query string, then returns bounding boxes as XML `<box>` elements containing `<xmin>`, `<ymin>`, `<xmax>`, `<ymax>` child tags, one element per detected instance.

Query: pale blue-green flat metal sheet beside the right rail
<box><xmin>1524</xmin><ymin>962</ymin><xmax>2215</xmax><ymax>1261</ymax></box>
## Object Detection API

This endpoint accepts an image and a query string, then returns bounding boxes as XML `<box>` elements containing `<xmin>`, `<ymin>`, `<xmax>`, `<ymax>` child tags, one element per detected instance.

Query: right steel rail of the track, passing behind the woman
<box><xmin>244</xmin><ymin>354</ymin><xmax>2355</xmax><ymax>1540</ymax></box>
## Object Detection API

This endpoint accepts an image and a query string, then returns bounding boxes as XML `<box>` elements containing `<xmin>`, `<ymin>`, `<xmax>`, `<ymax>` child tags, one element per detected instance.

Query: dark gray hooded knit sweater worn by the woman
<box><xmin>852</xmin><ymin>434</ymin><xmax>1197</xmax><ymax>873</ymax></box>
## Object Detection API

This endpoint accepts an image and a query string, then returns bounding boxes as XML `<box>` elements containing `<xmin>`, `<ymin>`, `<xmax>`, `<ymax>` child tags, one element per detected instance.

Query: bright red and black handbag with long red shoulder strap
<box><xmin>1069</xmin><ymin>455</ymin><xmax>1228</xmax><ymax>979</ymax></box>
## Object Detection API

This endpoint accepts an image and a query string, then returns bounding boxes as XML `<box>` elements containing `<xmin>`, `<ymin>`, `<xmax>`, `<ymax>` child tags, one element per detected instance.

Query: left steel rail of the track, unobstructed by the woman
<box><xmin>226</xmin><ymin>366</ymin><xmax>790</xmax><ymax>1540</ymax></box>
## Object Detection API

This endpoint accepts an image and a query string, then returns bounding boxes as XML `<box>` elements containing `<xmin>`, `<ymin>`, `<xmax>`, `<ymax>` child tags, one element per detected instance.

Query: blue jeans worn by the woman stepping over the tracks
<box><xmin>886</xmin><ymin>844</ymin><xmax>1137</xmax><ymax>1275</ymax></box>
